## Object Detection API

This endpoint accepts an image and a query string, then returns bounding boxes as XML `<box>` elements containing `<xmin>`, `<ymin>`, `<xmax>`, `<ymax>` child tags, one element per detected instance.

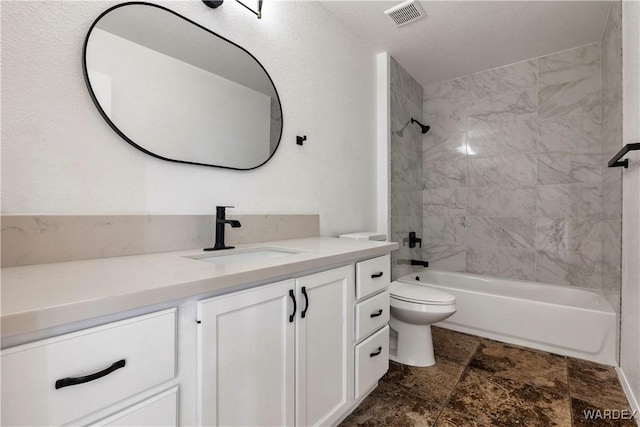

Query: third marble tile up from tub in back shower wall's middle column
<box><xmin>467</xmin><ymin>187</ymin><xmax>536</xmax><ymax>217</ymax></box>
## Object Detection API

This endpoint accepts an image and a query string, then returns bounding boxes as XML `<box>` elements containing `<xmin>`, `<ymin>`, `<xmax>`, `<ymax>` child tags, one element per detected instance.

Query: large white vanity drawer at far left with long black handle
<box><xmin>1</xmin><ymin>309</ymin><xmax>176</xmax><ymax>425</ymax></box>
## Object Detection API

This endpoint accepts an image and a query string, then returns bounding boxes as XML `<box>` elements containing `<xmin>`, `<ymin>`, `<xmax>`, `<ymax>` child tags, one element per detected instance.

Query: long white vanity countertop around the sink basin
<box><xmin>0</xmin><ymin>237</ymin><xmax>398</xmax><ymax>338</ymax></box>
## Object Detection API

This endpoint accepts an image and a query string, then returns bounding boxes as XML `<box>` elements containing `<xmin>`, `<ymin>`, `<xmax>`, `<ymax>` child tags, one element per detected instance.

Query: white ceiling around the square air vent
<box><xmin>322</xmin><ymin>0</ymin><xmax>609</xmax><ymax>86</ymax></box>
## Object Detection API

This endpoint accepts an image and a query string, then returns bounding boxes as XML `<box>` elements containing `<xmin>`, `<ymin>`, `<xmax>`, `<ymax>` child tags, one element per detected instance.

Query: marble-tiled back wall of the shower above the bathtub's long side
<box><xmin>422</xmin><ymin>30</ymin><xmax>620</xmax><ymax>288</ymax></box>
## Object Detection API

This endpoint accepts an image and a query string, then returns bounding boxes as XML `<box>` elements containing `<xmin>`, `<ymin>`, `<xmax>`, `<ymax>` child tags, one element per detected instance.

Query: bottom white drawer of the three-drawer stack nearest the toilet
<box><xmin>355</xmin><ymin>326</ymin><xmax>389</xmax><ymax>399</ymax></box>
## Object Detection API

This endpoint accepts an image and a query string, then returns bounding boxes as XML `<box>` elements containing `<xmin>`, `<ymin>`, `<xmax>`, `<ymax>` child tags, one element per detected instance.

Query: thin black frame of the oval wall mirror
<box><xmin>82</xmin><ymin>1</ymin><xmax>284</xmax><ymax>170</ymax></box>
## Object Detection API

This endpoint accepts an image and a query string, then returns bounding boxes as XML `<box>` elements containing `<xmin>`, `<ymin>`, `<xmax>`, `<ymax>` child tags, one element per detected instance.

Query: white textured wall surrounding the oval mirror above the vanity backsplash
<box><xmin>2</xmin><ymin>1</ymin><xmax>377</xmax><ymax>235</ymax></box>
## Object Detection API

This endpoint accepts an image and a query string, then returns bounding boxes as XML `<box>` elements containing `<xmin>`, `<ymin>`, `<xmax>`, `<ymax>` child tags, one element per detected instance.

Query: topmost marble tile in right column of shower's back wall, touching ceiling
<box><xmin>538</xmin><ymin>43</ymin><xmax>600</xmax><ymax>86</ymax></box>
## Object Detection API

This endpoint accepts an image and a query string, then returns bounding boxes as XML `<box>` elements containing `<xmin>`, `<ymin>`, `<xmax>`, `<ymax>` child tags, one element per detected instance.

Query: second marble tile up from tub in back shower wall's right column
<box><xmin>536</xmin><ymin>218</ymin><xmax>602</xmax><ymax>254</ymax></box>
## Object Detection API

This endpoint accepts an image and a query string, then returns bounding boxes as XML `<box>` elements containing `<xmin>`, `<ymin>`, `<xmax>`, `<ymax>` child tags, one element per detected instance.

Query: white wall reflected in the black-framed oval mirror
<box><xmin>87</xmin><ymin>28</ymin><xmax>271</xmax><ymax>169</ymax></box>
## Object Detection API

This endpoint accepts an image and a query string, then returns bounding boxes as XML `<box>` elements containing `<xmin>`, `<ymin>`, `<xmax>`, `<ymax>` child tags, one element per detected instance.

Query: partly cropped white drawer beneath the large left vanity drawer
<box><xmin>91</xmin><ymin>387</ymin><xmax>178</xmax><ymax>427</ymax></box>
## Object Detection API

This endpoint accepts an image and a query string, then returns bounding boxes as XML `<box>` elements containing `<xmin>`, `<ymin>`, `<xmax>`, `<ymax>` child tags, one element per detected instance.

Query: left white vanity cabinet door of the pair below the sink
<box><xmin>198</xmin><ymin>280</ymin><xmax>300</xmax><ymax>426</ymax></box>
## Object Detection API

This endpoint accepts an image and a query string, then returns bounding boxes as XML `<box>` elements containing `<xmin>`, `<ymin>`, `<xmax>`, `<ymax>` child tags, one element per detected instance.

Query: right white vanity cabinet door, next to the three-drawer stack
<box><xmin>296</xmin><ymin>266</ymin><xmax>355</xmax><ymax>426</ymax></box>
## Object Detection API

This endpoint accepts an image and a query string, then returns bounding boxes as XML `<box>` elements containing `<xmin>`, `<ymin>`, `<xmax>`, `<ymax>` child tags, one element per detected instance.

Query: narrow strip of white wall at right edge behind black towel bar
<box><xmin>620</xmin><ymin>1</ymin><xmax>640</xmax><ymax>409</ymax></box>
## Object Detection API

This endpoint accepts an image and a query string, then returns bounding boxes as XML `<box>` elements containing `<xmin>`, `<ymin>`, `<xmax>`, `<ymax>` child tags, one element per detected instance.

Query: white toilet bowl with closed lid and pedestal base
<box><xmin>389</xmin><ymin>282</ymin><xmax>456</xmax><ymax>366</ymax></box>
